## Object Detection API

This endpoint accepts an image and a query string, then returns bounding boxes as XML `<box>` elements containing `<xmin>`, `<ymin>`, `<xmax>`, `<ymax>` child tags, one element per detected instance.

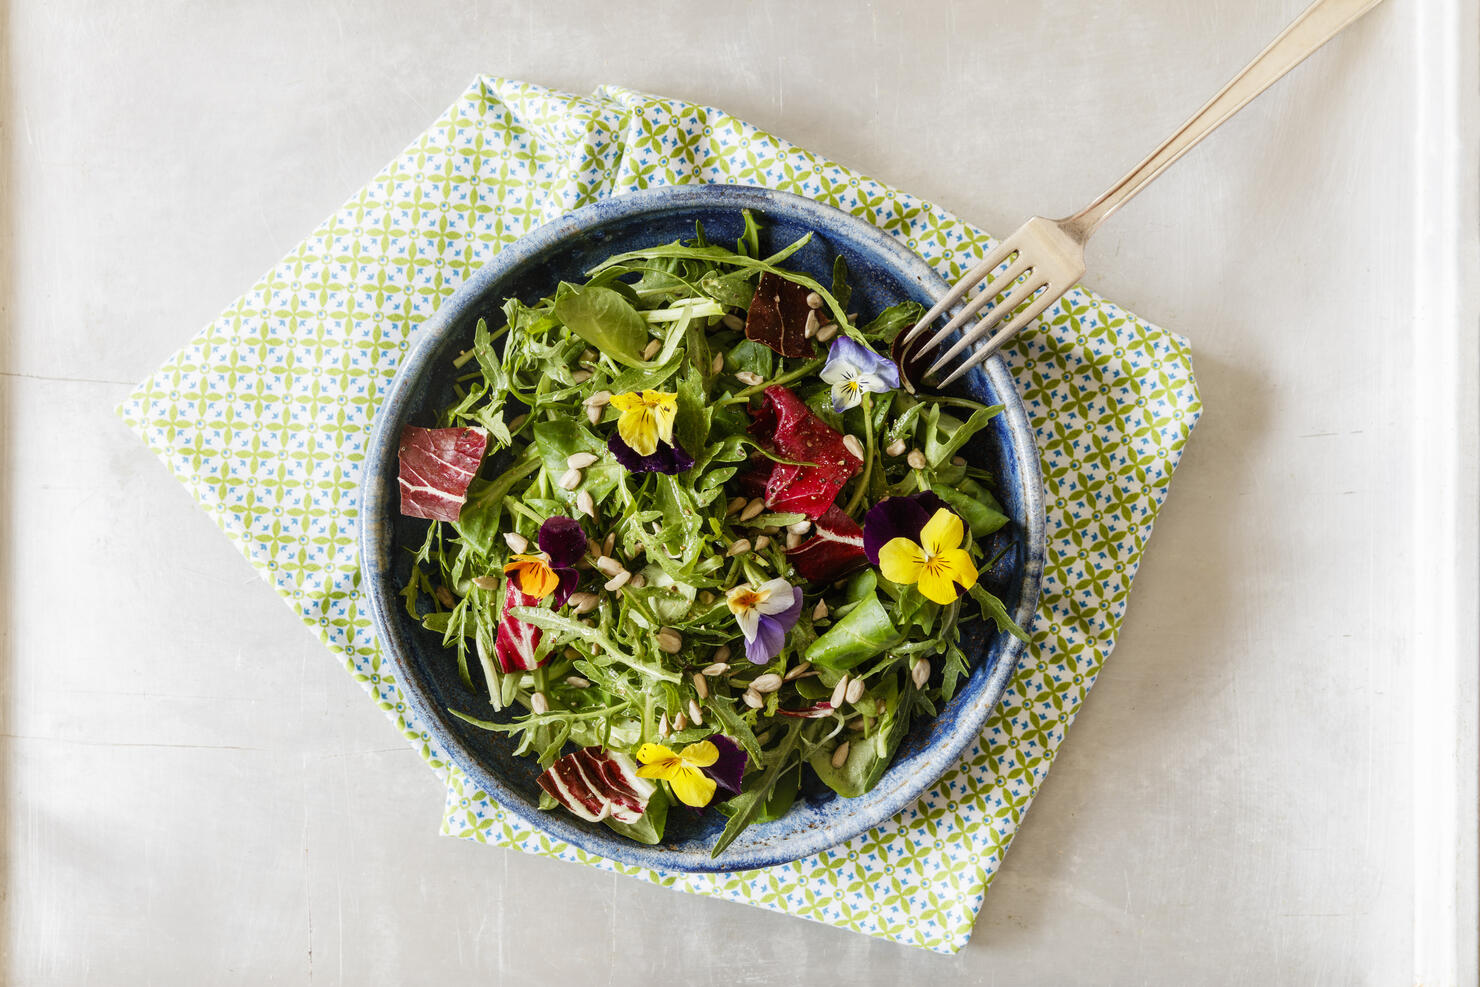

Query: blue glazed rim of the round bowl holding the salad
<box><xmin>357</xmin><ymin>185</ymin><xmax>1046</xmax><ymax>873</ymax></box>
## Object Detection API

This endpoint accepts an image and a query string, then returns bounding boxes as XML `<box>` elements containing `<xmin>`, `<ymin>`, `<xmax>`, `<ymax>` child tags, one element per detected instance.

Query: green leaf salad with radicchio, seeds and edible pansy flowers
<box><xmin>400</xmin><ymin>213</ymin><xmax>1026</xmax><ymax>855</ymax></box>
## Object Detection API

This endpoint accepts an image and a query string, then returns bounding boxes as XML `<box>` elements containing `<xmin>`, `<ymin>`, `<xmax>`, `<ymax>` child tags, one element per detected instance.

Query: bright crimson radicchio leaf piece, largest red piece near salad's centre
<box><xmin>750</xmin><ymin>385</ymin><xmax>863</xmax><ymax>519</ymax></box>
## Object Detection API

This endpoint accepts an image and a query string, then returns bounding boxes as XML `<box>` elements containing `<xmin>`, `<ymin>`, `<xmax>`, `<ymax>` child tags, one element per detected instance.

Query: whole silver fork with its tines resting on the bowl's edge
<box><xmin>895</xmin><ymin>0</ymin><xmax>1382</xmax><ymax>388</ymax></box>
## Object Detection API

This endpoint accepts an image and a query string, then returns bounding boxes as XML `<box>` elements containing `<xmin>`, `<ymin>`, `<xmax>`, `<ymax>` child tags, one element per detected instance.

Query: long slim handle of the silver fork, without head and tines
<box><xmin>1058</xmin><ymin>0</ymin><xmax>1382</xmax><ymax>243</ymax></box>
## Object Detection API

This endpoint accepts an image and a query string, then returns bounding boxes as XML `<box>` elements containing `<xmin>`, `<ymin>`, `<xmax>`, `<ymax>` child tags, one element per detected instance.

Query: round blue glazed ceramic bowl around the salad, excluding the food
<box><xmin>360</xmin><ymin>185</ymin><xmax>1043</xmax><ymax>872</ymax></box>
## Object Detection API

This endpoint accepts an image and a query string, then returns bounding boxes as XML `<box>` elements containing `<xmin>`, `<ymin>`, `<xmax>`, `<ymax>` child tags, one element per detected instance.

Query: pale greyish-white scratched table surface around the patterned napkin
<box><xmin>0</xmin><ymin>0</ymin><xmax>1474</xmax><ymax>984</ymax></box>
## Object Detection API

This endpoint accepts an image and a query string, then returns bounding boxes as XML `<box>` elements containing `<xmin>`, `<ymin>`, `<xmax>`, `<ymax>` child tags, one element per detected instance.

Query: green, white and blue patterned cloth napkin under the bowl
<box><xmin>120</xmin><ymin>78</ymin><xmax>1200</xmax><ymax>953</ymax></box>
